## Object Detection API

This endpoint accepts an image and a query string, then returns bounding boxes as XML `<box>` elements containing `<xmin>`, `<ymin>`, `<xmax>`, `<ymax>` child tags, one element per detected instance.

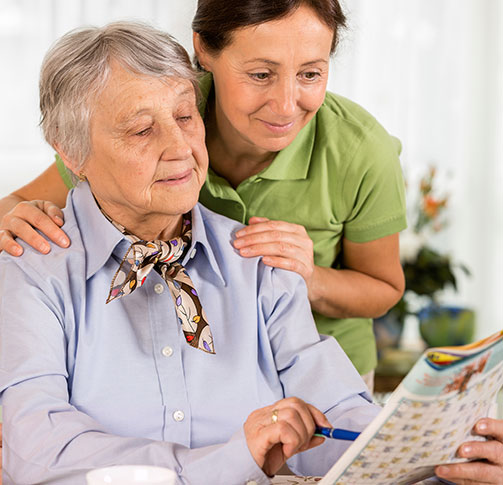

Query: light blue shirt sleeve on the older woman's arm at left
<box><xmin>0</xmin><ymin>257</ymin><xmax>269</xmax><ymax>485</ymax></box>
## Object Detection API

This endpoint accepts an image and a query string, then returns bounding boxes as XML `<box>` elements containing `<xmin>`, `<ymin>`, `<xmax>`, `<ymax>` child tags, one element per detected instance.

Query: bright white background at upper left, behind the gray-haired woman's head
<box><xmin>0</xmin><ymin>0</ymin><xmax>196</xmax><ymax>196</ymax></box>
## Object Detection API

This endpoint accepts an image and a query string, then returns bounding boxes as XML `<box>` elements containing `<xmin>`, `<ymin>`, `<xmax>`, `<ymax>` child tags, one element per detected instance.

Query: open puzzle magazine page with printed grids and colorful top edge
<box><xmin>318</xmin><ymin>332</ymin><xmax>503</xmax><ymax>485</ymax></box>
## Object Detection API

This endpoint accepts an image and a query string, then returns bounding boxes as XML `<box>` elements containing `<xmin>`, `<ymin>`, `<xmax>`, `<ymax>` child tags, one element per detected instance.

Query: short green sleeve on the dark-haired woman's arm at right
<box><xmin>335</xmin><ymin>122</ymin><xmax>407</xmax><ymax>243</ymax></box>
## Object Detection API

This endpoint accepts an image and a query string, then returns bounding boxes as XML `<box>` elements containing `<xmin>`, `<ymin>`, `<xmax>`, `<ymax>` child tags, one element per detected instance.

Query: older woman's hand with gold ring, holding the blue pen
<box><xmin>244</xmin><ymin>398</ymin><xmax>330</xmax><ymax>476</ymax></box>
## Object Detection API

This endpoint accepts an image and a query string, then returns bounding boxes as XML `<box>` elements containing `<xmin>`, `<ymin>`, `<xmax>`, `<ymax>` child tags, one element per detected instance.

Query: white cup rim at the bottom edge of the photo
<box><xmin>86</xmin><ymin>465</ymin><xmax>176</xmax><ymax>485</ymax></box>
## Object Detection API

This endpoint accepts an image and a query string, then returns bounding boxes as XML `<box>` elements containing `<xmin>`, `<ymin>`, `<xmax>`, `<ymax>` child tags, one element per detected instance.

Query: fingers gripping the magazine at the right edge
<box><xmin>435</xmin><ymin>418</ymin><xmax>503</xmax><ymax>485</ymax></box>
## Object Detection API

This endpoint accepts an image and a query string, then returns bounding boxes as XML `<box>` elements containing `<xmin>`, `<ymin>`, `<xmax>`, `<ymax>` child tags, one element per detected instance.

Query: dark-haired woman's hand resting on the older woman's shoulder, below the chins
<box><xmin>234</xmin><ymin>217</ymin><xmax>314</xmax><ymax>288</ymax></box>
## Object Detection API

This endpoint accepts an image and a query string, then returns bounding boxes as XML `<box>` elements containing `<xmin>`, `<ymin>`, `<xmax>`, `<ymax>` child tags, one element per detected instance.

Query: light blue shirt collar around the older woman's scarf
<box><xmin>71</xmin><ymin>182</ymin><xmax>225</xmax><ymax>286</ymax></box>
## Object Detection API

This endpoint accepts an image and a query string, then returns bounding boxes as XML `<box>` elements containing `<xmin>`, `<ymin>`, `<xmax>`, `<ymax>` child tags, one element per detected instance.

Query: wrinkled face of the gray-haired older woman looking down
<box><xmin>83</xmin><ymin>63</ymin><xmax>208</xmax><ymax>225</ymax></box>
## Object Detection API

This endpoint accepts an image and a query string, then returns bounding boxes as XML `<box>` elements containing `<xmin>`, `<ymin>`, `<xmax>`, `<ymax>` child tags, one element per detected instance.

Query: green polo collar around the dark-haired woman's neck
<box><xmin>199</xmin><ymin>73</ymin><xmax>316</xmax><ymax>180</ymax></box>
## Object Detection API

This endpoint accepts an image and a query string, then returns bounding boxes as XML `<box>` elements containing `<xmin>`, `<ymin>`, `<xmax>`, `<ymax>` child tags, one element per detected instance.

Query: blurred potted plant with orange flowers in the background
<box><xmin>374</xmin><ymin>166</ymin><xmax>475</xmax><ymax>349</ymax></box>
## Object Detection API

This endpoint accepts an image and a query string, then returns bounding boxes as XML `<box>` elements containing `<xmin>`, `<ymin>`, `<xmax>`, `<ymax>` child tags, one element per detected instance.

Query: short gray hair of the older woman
<box><xmin>39</xmin><ymin>22</ymin><xmax>198</xmax><ymax>171</ymax></box>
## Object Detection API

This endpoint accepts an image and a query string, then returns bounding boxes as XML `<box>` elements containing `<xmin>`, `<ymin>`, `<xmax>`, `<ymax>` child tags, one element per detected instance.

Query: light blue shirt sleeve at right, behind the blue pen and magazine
<box><xmin>259</xmin><ymin>262</ymin><xmax>380</xmax><ymax>475</ymax></box>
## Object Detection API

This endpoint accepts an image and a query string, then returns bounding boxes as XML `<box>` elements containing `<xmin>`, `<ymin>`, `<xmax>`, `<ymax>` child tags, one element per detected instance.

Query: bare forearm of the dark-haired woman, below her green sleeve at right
<box><xmin>309</xmin><ymin>266</ymin><xmax>403</xmax><ymax>318</ymax></box>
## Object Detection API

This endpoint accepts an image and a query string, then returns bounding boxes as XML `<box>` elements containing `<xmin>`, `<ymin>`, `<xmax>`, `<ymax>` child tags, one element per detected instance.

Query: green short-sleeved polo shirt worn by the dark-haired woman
<box><xmin>58</xmin><ymin>75</ymin><xmax>406</xmax><ymax>374</ymax></box>
